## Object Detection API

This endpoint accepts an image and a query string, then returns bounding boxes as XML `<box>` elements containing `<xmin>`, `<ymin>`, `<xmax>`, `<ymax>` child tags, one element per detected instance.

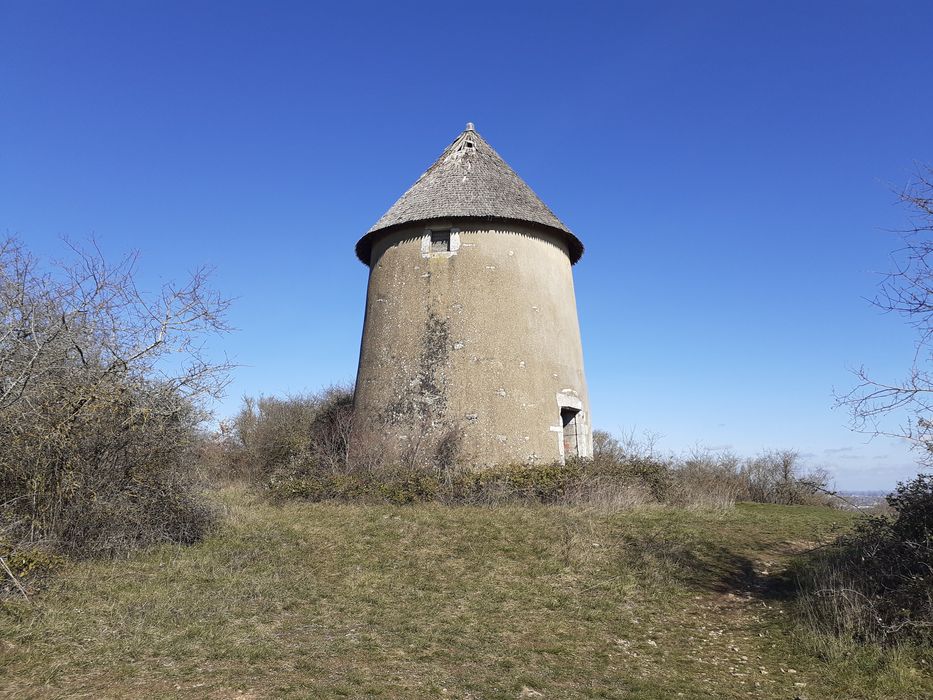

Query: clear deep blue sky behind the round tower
<box><xmin>0</xmin><ymin>0</ymin><xmax>933</xmax><ymax>488</ymax></box>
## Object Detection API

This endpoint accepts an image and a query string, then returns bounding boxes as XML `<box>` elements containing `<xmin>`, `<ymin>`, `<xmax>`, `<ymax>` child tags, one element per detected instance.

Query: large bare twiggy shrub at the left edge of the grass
<box><xmin>0</xmin><ymin>240</ymin><xmax>230</xmax><ymax>554</ymax></box>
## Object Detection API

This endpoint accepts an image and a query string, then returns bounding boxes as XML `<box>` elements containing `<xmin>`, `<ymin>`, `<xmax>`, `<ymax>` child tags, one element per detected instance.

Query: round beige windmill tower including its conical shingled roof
<box><xmin>351</xmin><ymin>124</ymin><xmax>593</xmax><ymax>467</ymax></box>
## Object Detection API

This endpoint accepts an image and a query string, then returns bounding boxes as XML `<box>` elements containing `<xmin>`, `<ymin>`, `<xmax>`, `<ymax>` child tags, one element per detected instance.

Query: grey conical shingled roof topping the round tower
<box><xmin>356</xmin><ymin>124</ymin><xmax>583</xmax><ymax>264</ymax></box>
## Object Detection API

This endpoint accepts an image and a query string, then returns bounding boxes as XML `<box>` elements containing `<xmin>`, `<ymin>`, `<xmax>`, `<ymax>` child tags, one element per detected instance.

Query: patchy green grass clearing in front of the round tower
<box><xmin>0</xmin><ymin>489</ymin><xmax>933</xmax><ymax>699</ymax></box>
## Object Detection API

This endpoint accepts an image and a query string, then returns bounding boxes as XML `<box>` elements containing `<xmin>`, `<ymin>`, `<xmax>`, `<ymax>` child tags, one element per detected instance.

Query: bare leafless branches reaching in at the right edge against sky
<box><xmin>837</xmin><ymin>167</ymin><xmax>933</xmax><ymax>465</ymax></box>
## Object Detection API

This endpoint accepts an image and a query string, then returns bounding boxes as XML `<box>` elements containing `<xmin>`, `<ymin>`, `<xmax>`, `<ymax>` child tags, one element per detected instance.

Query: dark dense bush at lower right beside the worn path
<box><xmin>796</xmin><ymin>474</ymin><xmax>933</xmax><ymax>644</ymax></box>
